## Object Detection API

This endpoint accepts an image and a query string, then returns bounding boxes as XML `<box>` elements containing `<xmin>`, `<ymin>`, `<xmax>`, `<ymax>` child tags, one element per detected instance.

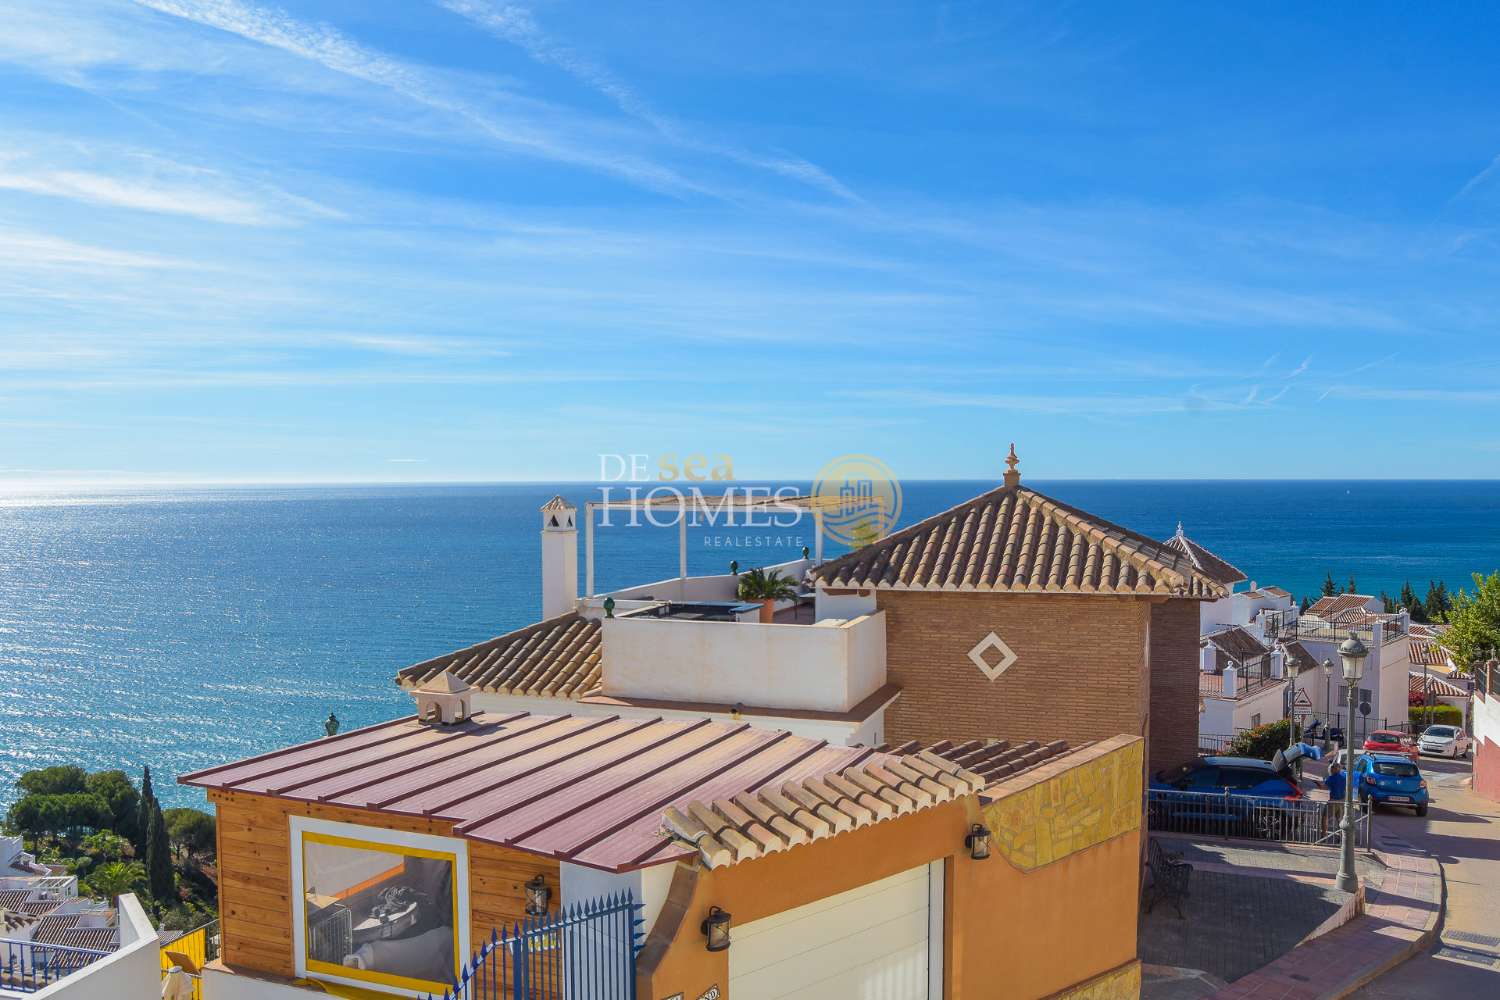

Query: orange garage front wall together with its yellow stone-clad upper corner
<box><xmin>641</xmin><ymin>736</ymin><xmax>1143</xmax><ymax>1000</ymax></box>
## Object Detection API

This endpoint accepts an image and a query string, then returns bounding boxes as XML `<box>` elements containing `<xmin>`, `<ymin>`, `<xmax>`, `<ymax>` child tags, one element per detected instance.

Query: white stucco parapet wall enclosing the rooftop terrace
<box><xmin>602</xmin><ymin>612</ymin><xmax>885</xmax><ymax>712</ymax></box>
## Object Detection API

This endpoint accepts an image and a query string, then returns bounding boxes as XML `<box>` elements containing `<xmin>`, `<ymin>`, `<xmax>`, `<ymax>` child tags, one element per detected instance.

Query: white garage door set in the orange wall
<box><xmin>729</xmin><ymin>861</ymin><xmax>944</xmax><ymax>1000</ymax></box>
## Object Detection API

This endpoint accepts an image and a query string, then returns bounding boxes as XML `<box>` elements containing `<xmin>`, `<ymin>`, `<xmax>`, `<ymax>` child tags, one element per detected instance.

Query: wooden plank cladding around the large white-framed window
<box><xmin>209</xmin><ymin>790</ymin><xmax>563</xmax><ymax>978</ymax></box>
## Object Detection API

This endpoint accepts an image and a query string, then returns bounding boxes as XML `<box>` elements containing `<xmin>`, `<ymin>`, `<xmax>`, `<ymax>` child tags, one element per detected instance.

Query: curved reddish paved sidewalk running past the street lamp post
<box><xmin>1212</xmin><ymin>834</ymin><xmax>1443</xmax><ymax>1000</ymax></box>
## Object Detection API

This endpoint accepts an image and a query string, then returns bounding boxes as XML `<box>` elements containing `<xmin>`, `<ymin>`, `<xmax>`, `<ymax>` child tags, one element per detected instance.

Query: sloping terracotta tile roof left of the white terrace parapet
<box><xmin>396</xmin><ymin>612</ymin><xmax>602</xmax><ymax>699</ymax></box>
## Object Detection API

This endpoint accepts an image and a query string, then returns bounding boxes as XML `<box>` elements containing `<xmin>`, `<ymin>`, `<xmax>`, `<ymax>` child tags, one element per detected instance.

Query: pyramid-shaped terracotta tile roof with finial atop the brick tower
<box><xmin>812</xmin><ymin>486</ymin><xmax>1227</xmax><ymax>598</ymax></box>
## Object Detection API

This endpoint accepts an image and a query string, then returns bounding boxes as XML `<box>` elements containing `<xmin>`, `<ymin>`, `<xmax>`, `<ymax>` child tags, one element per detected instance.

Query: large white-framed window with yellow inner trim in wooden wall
<box><xmin>291</xmin><ymin>816</ymin><xmax>468</xmax><ymax>996</ymax></box>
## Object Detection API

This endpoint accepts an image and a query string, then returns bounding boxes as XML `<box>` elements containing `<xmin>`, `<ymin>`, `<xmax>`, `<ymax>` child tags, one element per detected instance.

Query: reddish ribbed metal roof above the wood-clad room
<box><xmin>180</xmin><ymin>712</ymin><xmax>888</xmax><ymax>871</ymax></box>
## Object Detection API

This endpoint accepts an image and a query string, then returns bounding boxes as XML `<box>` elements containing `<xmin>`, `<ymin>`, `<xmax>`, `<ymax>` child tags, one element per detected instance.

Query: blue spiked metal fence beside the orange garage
<box><xmin>429</xmin><ymin>892</ymin><xmax>642</xmax><ymax>1000</ymax></box>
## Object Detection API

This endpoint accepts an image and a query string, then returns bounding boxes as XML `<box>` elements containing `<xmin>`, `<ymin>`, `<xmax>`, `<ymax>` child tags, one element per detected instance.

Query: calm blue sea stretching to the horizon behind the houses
<box><xmin>0</xmin><ymin>481</ymin><xmax>1500</xmax><ymax>804</ymax></box>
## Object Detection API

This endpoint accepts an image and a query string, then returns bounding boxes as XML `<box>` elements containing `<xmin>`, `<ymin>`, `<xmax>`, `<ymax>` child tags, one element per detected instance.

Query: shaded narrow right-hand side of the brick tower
<box><xmin>1149</xmin><ymin>600</ymin><xmax>1199</xmax><ymax>772</ymax></box>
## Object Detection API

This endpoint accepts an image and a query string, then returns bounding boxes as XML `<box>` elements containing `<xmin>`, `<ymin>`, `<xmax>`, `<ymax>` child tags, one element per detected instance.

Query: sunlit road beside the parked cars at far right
<box><xmin>1355</xmin><ymin>759</ymin><xmax>1500</xmax><ymax>1000</ymax></box>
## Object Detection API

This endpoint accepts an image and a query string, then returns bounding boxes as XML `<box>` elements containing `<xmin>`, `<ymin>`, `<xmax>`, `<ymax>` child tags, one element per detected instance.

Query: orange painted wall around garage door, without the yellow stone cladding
<box><xmin>641</xmin><ymin>743</ymin><xmax>1140</xmax><ymax>1000</ymax></box>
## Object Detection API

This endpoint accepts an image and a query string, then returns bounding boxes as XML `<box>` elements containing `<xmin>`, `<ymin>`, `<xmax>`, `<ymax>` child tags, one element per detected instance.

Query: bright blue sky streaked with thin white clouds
<box><xmin>0</xmin><ymin>0</ymin><xmax>1500</xmax><ymax>487</ymax></box>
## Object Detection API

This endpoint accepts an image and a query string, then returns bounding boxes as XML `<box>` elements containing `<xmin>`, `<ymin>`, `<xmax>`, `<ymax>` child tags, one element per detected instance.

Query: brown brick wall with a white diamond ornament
<box><xmin>876</xmin><ymin>591</ymin><xmax>1152</xmax><ymax>742</ymax></box>
